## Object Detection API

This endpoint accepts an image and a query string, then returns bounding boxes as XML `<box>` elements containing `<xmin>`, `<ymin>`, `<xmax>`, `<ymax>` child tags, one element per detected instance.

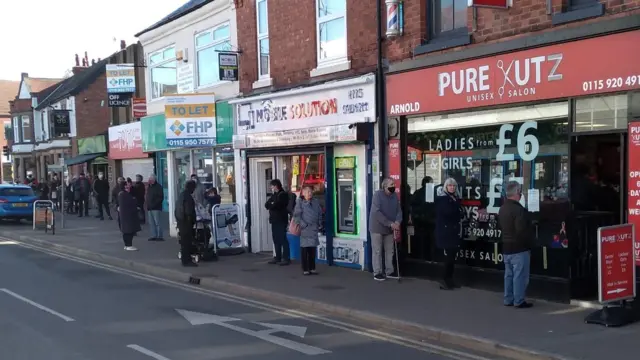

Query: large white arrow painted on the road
<box><xmin>176</xmin><ymin>309</ymin><xmax>331</xmax><ymax>355</ymax></box>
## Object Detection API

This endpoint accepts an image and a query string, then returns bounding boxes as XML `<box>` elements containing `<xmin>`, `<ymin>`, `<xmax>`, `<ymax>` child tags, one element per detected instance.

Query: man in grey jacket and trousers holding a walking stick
<box><xmin>369</xmin><ymin>178</ymin><xmax>402</xmax><ymax>281</ymax></box>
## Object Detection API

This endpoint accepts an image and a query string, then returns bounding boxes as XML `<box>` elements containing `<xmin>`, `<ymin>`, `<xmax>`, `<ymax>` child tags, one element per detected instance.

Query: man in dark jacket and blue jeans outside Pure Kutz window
<box><xmin>498</xmin><ymin>181</ymin><xmax>533</xmax><ymax>309</ymax></box>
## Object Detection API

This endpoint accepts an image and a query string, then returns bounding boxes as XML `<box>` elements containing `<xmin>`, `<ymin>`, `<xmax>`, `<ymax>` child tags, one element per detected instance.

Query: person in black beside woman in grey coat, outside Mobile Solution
<box><xmin>264</xmin><ymin>179</ymin><xmax>291</xmax><ymax>266</ymax></box>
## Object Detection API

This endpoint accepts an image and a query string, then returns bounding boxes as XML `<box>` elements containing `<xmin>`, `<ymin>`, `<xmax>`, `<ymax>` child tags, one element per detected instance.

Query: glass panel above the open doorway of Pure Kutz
<box><xmin>574</xmin><ymin>94</ymin><xmax>631</xmax><ymax>132</ymax></box>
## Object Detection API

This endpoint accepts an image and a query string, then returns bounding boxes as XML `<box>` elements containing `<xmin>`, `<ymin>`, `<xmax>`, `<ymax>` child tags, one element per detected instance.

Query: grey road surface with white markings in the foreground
<box><xmin>0</xmin><ymin>239</ymin><xmax>496</xmax><ymax>360</ymax></box>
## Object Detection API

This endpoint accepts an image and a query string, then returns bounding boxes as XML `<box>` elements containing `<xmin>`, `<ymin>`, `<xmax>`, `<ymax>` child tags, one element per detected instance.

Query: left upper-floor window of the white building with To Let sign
<box><xmin>149</xmin><ymin>46</ymin><xmax>178</xmax><ymax>99</ymax></box>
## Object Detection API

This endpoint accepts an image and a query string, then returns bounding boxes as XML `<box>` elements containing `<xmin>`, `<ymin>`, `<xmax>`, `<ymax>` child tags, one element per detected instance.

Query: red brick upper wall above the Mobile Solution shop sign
<box><xmin>236</xmin><ymin>0</ymin><xmax>376</xmax><ymax>94</ymax></box>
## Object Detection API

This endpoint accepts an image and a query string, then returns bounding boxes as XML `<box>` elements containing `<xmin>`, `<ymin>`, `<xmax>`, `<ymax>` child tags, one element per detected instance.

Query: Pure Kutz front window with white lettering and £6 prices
<box><xmin>406</xmin><ymin>112</ymin><xmax>570</xmax><ymax>273</ymax></box>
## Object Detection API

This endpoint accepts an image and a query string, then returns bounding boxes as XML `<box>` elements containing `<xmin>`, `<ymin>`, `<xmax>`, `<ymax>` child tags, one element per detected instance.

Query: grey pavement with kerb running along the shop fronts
<box><xmin>0</xmin><ymin>214</ymin><xmax>640</xmax><ymax>360</ymax></box>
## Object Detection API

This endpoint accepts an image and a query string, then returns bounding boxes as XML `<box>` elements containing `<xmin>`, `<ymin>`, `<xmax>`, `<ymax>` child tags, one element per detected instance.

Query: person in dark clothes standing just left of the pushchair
<box><xmin>174</xmin><ymin>180</ymin><xmax>198</xmax><ymax>266</ymax></box>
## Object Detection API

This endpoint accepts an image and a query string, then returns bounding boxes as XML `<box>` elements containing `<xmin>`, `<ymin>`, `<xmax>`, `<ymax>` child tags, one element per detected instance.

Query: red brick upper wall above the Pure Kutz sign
<box><xmin>385</xmin><ymin>0</ymin><xmax>640</xmax><ymax>62</ymax></box>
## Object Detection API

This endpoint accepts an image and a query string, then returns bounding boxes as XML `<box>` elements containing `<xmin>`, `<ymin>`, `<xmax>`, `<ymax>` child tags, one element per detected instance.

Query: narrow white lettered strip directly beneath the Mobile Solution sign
<box><xmin>233</xmin><ymin>125</ymin><xmax>358</xmax><ymax>149</ymax></box>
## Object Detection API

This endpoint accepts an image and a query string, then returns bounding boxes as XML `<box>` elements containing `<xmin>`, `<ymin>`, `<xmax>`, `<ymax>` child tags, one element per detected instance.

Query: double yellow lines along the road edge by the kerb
<box><xmin>10</xmin><ymin>241</ymin><xmax>493</xmax><ymax>360</ymax></box>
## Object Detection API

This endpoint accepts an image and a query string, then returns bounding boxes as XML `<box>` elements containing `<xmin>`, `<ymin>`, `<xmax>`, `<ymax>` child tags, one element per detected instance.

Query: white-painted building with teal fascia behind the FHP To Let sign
<box><xmin>136</xmin><ymin>0</ymin><xmax>239</xmax><ymax>236</ymax></box>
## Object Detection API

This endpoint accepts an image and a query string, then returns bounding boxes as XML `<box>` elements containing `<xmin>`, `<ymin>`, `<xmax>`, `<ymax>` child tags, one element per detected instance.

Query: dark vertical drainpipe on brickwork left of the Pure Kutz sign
<box><xmin>372</xmin><ymin>0</ymin><xmax>389</xmax><ymax>180</ymax></box>
